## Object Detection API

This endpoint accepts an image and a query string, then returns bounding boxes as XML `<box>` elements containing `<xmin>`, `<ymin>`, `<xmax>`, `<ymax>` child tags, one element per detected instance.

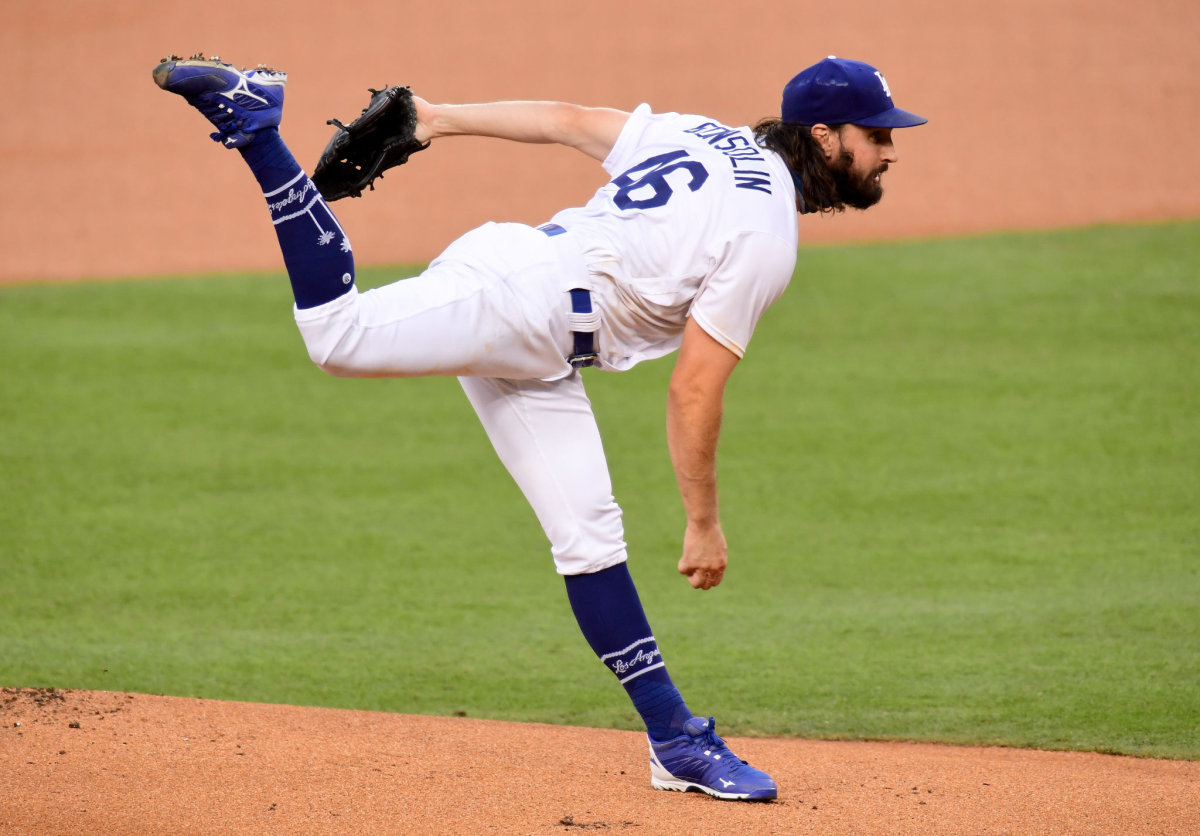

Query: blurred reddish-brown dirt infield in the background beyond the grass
<box><xmin>0</xmin><ymin>0</ymin><xmax>1200</xmax><ymax>281</ymax></box>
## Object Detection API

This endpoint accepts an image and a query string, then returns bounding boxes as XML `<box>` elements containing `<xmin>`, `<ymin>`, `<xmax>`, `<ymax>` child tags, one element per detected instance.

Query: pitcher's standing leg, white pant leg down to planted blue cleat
<box><xmin>460</xmin><ymin>373</ymin><xmax>776</xmax><ymax>800</ymax></box>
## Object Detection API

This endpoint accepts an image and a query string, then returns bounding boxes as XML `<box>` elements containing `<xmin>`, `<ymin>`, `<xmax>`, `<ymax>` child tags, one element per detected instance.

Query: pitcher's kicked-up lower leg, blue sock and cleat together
<box><xmin>154</xmin><ymin>55</ymin><xmax>354</xmax><ymax>308</ymax></box>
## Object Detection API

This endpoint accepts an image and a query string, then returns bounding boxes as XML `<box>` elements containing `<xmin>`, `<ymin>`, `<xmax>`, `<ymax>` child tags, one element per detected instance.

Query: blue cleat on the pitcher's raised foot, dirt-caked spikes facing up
<box><xmin>154</xmin><ymin>53</ymin><xmax>288</xmax><ymax>148</ymax></box>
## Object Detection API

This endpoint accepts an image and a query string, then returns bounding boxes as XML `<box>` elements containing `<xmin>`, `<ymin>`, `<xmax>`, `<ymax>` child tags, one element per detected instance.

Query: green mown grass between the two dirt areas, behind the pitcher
<box><xmin>0</xmin><ymin>223</ymin><xmax>1200</xmax><ymax>758</ymax></box>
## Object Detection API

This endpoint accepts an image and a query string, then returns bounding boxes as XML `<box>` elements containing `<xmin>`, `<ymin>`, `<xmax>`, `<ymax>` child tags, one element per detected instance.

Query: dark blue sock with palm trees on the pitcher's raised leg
<box><xmin>240</xmin><ymin>128</ymin><xmax>354</xmax><ymax>308</ymax></box>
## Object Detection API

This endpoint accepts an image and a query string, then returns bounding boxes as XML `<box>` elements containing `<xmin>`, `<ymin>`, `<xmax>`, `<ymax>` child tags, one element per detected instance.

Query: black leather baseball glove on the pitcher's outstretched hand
<box><xmin>312</xmin><ymin>88</ymin><xmax>430</xmax><ymax>203</ymax></box>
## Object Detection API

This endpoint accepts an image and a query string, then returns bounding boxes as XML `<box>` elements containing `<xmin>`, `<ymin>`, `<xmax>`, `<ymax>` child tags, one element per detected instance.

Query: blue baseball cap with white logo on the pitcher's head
<box><xmin>782</xmin><ymin>55</ymin><xmax>929</xmax><ymax>127</ymax></box>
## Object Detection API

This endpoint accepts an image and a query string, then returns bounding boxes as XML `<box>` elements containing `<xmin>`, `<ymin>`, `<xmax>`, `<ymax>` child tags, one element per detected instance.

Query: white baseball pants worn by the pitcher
<box><xmin>295</xmin><ymin>223</ymin><xmax>626</xmax><ymax>575</ymax></box>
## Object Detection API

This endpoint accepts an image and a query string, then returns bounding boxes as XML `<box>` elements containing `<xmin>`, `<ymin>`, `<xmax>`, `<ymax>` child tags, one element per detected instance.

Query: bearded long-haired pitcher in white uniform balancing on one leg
<box><xmin>154</xmin><ymin>54</ymin><xmax>925</xmax><ymax>800</ymax></box>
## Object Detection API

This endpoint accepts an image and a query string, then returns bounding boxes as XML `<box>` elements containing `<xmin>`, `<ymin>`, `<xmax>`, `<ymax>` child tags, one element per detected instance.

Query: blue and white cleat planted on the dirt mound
<box><xmin>650</xmin><ymin>717</ymin><xmax>779</xmax><ymax>801</ymax></box>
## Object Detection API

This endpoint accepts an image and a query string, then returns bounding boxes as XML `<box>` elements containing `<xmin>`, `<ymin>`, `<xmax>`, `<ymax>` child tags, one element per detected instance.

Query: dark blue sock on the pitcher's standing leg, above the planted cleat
<box><xmin>566</xmin><ymin>563</ymin><xmax>692</xmax><ymax>741</ymax></box>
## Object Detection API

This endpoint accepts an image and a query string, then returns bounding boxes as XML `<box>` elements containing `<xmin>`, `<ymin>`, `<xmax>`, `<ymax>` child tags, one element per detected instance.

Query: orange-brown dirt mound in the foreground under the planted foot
<box><xmin>0</xmin><ymin>688</ymin><xmax>1200</xmax><ymax>836</ymax></box>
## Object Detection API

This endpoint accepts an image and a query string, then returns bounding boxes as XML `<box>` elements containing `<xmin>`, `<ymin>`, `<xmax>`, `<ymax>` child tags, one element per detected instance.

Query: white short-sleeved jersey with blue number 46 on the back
<box><xmin>553</xmin><ymin>104</ymin><xmax>797</xmax><ymax>371</ymax></box>
